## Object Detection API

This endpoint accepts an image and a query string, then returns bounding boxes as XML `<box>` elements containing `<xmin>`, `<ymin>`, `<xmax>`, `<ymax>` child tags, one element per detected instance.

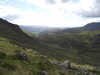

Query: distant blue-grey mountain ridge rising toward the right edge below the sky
<box><xmin>40</xmin><ymin>22</ymin><xmax>100</xmax><ymax>35</ymax></box>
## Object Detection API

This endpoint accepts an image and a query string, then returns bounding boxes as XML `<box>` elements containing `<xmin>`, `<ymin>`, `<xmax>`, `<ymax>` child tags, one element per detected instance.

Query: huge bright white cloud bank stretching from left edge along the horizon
<box><xmin>0</xmin><ymin>0</ymin><xmax>89</xmax><ymax>27</ymax></box>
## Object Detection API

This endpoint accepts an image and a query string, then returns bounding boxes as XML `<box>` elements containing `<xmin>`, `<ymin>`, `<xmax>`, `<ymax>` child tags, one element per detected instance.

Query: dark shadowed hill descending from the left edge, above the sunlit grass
<box><xmin>0</xmin><ymin>19</ymin><xmax>37</xmax><ymax>47</ymax></box>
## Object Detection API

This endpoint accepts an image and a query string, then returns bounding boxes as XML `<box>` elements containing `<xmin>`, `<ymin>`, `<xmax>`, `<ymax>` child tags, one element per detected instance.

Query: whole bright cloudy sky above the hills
<box><xmin>0</xmin><ymin>0</ymin><xmax>100</xmax><ymax>27</ymax></box>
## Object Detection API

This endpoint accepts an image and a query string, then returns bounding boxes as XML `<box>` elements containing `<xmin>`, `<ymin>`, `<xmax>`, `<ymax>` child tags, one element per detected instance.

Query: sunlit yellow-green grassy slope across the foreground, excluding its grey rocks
<box><xmin>0</xmin><ymin>37</ymin><xmax>99</xmax><ymax>75</ymax></box>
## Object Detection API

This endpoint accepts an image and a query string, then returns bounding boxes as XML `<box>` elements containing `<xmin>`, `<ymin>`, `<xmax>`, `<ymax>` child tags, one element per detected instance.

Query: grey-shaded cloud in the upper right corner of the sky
<box><xmin>79</xmin><ymin>0</ymin><xmax>100</xmax><ymax>18</ymax></box>
